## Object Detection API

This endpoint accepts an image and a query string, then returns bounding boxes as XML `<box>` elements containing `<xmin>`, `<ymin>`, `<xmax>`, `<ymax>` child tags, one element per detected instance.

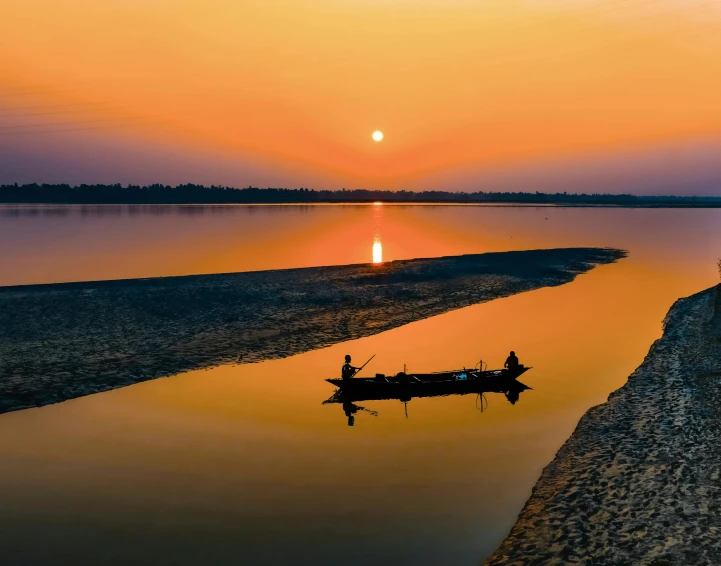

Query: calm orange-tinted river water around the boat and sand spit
<box><xmin>0</xmin><ymin>205</ymin><xmax>721</xmax><ymax>565</ymax></box>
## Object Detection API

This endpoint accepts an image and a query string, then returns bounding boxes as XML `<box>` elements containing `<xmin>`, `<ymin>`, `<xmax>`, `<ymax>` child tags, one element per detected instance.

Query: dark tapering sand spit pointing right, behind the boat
<box><xmin>0</xmin><ymin>248</ymin><xmax>625</xmax><ymax>413</ymax></box>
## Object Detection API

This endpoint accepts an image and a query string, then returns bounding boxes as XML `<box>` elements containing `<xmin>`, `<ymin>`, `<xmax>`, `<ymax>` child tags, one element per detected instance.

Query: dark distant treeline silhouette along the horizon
<box><xmin>0</xmin><ymin>183</ymin><xmax>721</xmax><ymax>207</ymax></box>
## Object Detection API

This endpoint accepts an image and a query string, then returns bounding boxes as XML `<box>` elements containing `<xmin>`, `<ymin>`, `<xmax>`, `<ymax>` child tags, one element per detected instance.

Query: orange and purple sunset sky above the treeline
<box><xmin>0</xmin><ymin>0</ymin><xmax>721</xmax><ymax>195</ymax></box>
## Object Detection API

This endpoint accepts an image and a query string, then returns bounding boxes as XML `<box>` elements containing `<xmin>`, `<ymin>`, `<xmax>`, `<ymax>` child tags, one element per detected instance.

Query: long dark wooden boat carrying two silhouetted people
<box><xmin>326</xmin><ymin>366</ymin><xmax>531</xmax><ymax>402</ymax></box>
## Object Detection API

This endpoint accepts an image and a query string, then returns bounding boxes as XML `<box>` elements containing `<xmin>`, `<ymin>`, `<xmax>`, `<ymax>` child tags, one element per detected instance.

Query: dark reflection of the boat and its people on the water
<box><xmin>323</xmin><ymin>379</ymin><xmax>531</xmax><ymax>426</ymax></box>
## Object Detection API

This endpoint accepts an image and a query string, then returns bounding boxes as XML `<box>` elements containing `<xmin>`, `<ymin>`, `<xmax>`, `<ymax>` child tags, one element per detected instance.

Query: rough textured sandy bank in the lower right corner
<box><xmin>486</xmin><ymin>287</ymin><xmax>721</xmax><ymax>566</ymax></box>
